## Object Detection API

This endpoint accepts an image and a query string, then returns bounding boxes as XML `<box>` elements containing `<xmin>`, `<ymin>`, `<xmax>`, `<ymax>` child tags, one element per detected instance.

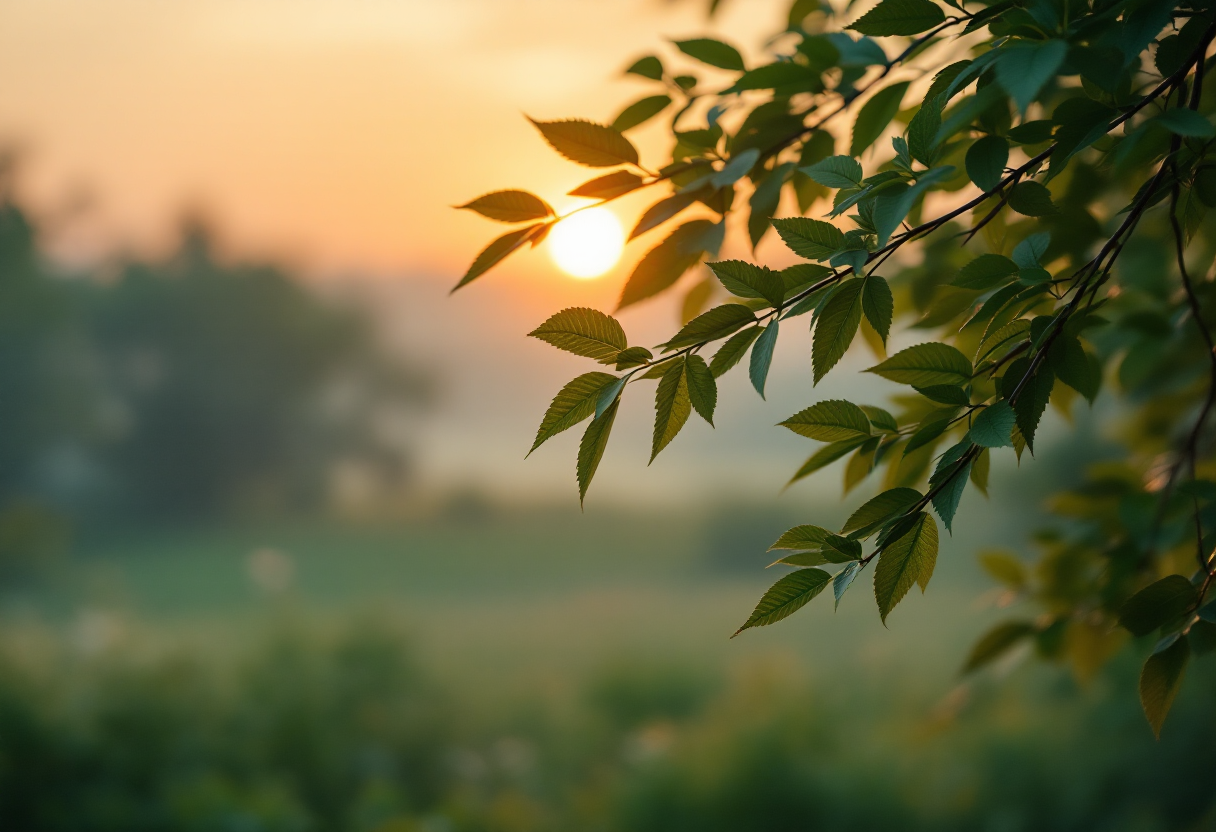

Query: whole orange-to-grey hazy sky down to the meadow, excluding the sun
<box><xmin>0</xmin><ymin>0</ymin><xmax>1036</xmax><ymax>500</ymax></box>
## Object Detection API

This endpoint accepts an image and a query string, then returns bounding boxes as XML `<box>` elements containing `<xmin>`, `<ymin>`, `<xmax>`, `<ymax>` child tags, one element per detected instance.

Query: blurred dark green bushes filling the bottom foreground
<box><xmin>0</xmin><ymin>622</ymin><xmax>1216</xmax><ymax>832</ymax></box>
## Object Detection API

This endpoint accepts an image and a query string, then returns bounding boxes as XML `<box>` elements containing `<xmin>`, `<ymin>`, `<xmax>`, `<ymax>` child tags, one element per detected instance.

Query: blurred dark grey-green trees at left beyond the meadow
<box><xmin>0</xmin><ymin>172</ymin><xmax>426</xmax><ymax>570</ymax></box>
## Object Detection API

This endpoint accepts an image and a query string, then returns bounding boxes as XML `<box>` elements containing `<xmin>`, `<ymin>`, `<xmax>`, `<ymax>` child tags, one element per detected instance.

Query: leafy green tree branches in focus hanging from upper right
<box><xmin>460</xmin><ymin>0</ymin><xmax>1216</xmax><ymax>731</ymax></box>
